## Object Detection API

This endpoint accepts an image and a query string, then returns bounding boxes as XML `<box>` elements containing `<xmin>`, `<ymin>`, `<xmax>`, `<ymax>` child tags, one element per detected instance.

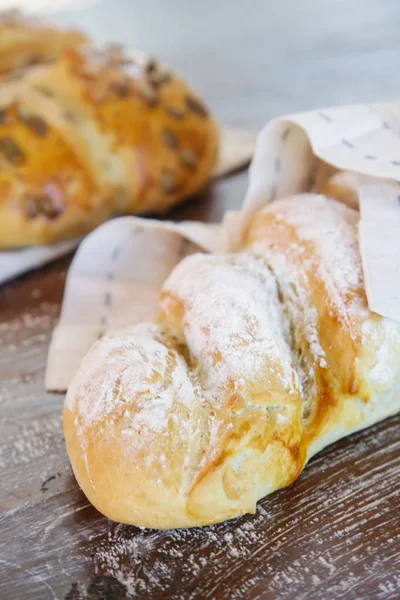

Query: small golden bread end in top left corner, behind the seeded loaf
<box><xmin>0</xmin><ymin>10</ymin><xmax>87</xmax><ymax>77</ymax></box>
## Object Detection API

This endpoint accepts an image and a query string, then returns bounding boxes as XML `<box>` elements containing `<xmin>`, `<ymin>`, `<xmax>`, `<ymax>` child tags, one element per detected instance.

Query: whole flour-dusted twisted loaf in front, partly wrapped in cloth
<box><xmin>64</xmin><ymin>194</ymin><xmax>400</xmax><ymax>529</ymax></box>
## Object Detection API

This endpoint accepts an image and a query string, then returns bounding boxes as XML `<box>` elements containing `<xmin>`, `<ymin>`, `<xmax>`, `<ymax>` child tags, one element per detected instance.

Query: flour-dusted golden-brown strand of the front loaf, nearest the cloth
<box><xmin>246</xmin><ymin>196</ymin><xmax>368</xmax><ymax>445</ymax></box>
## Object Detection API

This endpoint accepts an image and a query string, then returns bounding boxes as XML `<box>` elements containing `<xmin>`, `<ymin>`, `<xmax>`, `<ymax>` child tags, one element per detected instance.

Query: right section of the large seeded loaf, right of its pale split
<box><xmin>31</xmin><ymin>45</ymin><xmax>218</xmax><ymax>214</ymax></box>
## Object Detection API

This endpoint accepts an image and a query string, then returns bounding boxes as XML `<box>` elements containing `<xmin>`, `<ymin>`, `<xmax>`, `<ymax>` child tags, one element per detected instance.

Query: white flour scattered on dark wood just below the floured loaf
<box><xmin>93</xmin><ymin>506</ymin><xmax>270</xmax><ymax>598</ymax></box>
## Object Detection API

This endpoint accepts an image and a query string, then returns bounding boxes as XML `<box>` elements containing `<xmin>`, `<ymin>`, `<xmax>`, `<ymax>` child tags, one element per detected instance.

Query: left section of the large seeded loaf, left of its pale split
<box><xmin>0</xmin><ymin>84</ymin><xmax>112</xmax><ymax>248</ymax></box>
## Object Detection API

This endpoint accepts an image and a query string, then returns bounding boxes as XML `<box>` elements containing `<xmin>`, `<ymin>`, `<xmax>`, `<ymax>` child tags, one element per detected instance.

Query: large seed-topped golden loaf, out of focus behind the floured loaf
<box><xmin>0</xmin><ymin>27</ymin><xmax>218</xmax><ymax>248</ymax></box>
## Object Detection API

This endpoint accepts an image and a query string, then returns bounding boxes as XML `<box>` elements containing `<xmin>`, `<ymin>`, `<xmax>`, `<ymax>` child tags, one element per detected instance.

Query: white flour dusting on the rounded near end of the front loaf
<box><xmin>66</xmin><ymin>325</ymin><xmax>194</xmax><ymax>431</ymax></box>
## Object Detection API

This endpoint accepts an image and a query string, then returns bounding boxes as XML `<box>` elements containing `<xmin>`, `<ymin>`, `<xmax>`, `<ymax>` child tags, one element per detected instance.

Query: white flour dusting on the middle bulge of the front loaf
<box><xmin>160</xmin><ymin>254</ymin><xmax>297</xmax><ymax>394</ymax></box>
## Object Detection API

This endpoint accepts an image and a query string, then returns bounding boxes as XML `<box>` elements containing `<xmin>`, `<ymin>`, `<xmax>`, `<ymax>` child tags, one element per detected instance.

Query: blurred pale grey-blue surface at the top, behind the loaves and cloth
<box><xmin>52</xmin><ymin>0</ymin><xmax>400</xmax><ymax>129</ymax></box>
